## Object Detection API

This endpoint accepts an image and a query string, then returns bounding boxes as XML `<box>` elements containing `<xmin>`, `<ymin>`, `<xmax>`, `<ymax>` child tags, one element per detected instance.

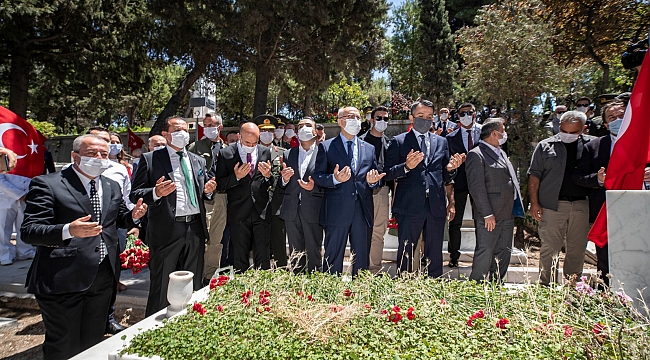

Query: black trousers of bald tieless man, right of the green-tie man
<box><xmin>228</xmin><ymin>216</ymin><xmax>270</xmax><ymax>272</ymax></box>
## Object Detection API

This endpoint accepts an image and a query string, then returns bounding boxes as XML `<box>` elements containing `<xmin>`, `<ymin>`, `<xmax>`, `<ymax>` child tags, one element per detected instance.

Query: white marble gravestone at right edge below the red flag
<box><xmin>607</xmin><ymin>190</ymin><xmax>650</xmax><ymax>315</ymax></box>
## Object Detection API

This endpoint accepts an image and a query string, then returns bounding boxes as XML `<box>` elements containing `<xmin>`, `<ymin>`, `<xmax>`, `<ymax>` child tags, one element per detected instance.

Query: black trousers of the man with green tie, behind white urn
<box><xmin>145</xmin><ymin>220</ymin><xmax>205</xmax><ymax>316</ymax></box>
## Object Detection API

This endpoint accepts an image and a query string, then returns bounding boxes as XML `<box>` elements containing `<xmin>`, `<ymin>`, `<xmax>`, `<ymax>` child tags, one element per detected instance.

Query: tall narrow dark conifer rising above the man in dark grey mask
<box><xmin>418</xmin><ymin>0</ymin><xmax>456</xmax><ymax>104</ymax></box>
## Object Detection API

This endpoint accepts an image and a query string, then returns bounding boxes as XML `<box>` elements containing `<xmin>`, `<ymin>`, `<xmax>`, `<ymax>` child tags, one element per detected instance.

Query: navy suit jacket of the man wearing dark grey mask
<box><xmin>384</xmin><ymin>130</ymin><xmax>457</xmax><ymax>217</ymax></box>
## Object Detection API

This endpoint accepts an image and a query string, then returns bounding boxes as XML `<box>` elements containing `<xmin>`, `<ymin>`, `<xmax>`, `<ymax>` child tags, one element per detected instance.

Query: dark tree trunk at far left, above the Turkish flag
<box><xmin>9</xmin><ymin>47</ymin><xmax>30</xmax><ymax>118</ymax></box>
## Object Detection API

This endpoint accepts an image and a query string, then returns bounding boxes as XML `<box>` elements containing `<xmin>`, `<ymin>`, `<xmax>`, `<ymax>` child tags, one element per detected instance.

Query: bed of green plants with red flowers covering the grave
<box><xmin>122</xmin><ymin>270</ymin><xmax>650</xmax><ymax>360</ymax></box>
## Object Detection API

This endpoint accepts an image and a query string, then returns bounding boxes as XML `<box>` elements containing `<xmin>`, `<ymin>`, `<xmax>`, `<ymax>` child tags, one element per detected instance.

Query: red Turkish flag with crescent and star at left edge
<box><xmin>0</xmin><ymin>106</ymin><xmax>47</xmax><ymax>178</ymax></box>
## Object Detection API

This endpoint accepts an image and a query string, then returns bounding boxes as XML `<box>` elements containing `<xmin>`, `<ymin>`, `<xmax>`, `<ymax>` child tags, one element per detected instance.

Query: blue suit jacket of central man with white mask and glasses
<box><xmin>312</xmin><ymin>136</ymin><xmax>381</xmax><ymax>227</ymax></box>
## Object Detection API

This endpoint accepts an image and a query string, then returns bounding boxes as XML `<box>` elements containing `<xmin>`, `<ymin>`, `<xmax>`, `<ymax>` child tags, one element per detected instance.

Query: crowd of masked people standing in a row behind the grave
<box><xmin>0</xmin><ymin>96</ymin><xmax>650</xmax><ymax>359</ymax></box>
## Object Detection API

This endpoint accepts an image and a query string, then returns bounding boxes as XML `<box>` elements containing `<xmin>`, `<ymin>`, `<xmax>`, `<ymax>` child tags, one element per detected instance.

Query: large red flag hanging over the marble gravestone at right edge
<box><xmin>588</xmin><ymin>54</ymin><xmax>650</xmax><ymax>247</ymax></box>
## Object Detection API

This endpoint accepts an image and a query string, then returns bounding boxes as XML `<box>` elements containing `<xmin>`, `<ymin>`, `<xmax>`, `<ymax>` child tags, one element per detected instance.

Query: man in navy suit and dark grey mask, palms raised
<box><xmin>384</xmin><ymin>100</ymin><xmax>465</xmax><ymax>277</ymax></box>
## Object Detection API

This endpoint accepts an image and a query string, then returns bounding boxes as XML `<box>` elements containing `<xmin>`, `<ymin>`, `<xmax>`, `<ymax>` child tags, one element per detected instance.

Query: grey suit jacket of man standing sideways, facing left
<box><xmin>465</xmin><ymin>143</ymin><xmax>515</xmax><ymax>221</ymax></box>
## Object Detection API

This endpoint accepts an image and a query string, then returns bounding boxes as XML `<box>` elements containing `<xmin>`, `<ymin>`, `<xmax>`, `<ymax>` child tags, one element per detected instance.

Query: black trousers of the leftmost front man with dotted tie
<box><xmin>35</xmin><ymin>257</ymin><xmax>116</xmax><ymax>360</ymax></box>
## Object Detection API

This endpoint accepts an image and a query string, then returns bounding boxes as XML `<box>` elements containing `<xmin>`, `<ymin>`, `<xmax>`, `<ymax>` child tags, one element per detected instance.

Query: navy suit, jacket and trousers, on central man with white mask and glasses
<box><xmin>313</xmin><ymin>136</ymin><xmax>379</xmax><ymax>275</ymax></box>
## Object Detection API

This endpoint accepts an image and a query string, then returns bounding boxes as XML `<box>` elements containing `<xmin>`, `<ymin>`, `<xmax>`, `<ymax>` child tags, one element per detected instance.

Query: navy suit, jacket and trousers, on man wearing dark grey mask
<box><xmin>384</xmin><ymin>130</ymin><xmax>455</xmax><ymax>277</ymax></box>
